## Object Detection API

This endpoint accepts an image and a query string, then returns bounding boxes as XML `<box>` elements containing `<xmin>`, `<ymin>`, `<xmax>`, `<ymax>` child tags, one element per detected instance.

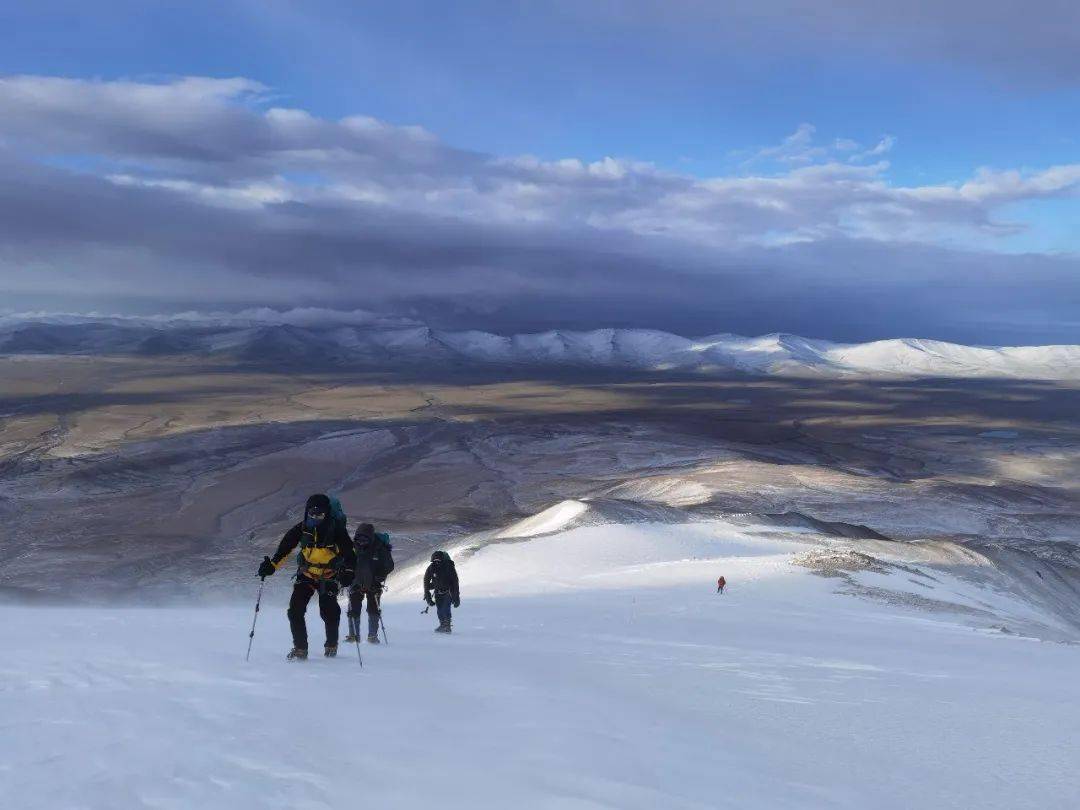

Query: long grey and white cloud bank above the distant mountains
<box><xmin>0</xmin><ymin>77</ymin><xmax>1080</xmax><ymax>340</ymax></box>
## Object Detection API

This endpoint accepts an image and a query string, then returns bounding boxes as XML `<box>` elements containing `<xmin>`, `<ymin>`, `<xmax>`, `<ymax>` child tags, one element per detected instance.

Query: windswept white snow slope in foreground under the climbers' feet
<box><xmin>0</xmin><ymin>520</ymin><xmax>1080</xmax><ymax>810</ymax></box>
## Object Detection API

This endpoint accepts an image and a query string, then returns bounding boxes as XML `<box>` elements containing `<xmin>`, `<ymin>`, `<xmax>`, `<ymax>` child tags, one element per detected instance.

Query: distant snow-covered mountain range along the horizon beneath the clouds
<box><xmin>0</xmin><ymin>312</ymin><xmax>1080</xmax><ymax>380</ymax></box>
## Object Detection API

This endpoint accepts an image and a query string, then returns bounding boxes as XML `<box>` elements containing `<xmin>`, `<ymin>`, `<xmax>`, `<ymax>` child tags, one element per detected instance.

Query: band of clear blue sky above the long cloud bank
<box><xmin>0</xmin><ymin>2</ymin><xmax>1080</xmax><ymax>183</ymax></box>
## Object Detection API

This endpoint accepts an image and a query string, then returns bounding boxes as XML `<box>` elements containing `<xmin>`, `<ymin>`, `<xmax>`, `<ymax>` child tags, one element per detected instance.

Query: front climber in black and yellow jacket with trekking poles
<box><xmin>259</xmin><ymin>495</ymin><xmax>356</xmax><ymax>661</ymax></box>
